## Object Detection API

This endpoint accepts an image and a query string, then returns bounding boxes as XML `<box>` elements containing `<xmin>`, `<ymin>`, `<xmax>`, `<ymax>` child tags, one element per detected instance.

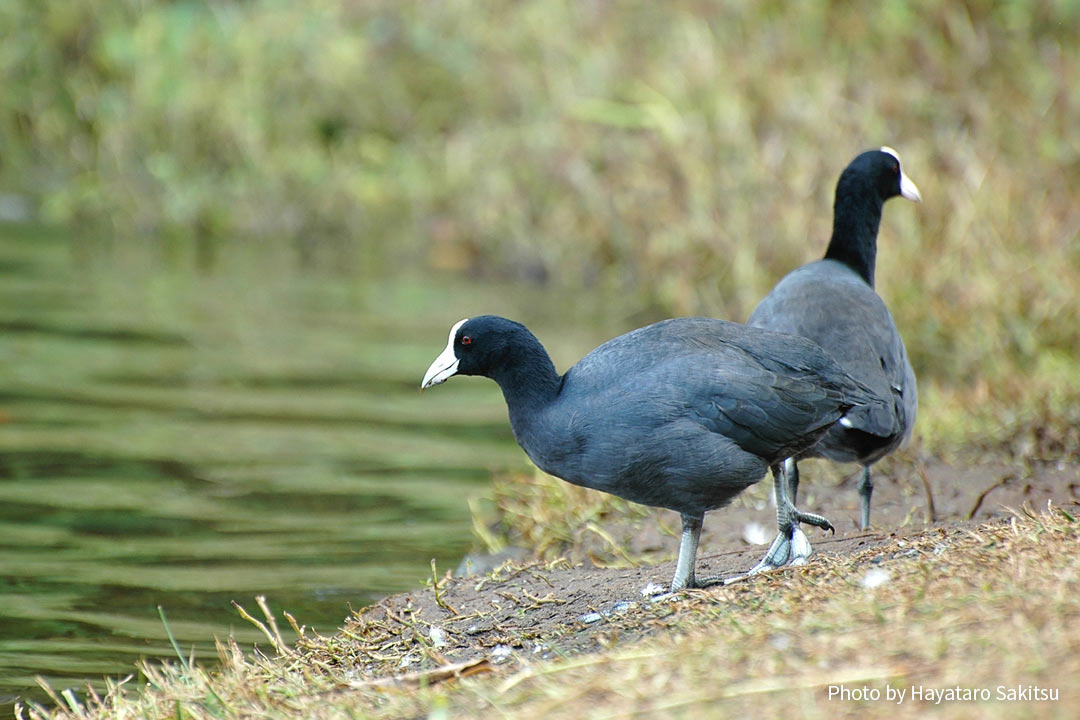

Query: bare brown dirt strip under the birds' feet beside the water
<box><xmin>309</xmin><ymin>462</ymin><xmax>1080</xmax><ymax>681</ymax></box>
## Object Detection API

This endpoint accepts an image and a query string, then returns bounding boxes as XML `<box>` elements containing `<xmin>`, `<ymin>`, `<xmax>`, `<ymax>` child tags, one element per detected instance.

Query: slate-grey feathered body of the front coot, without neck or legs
<box><xmin>518</xmin><ymin>317</ymin><xmax>872</xmax><ymax>512</ymax></box>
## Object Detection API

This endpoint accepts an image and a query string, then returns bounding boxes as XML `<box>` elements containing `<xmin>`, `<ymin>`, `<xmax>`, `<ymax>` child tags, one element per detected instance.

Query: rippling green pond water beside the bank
<box><xmin>0</xmin><ymin>226</ymin><xmax>617</xmax><ymax>708</ymax></box>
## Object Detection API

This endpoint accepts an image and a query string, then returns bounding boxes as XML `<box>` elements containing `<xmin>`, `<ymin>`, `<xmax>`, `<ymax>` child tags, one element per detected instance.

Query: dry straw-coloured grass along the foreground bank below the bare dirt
<box><xmin>24</xmin><ymin>506</ymin><xmax>1080</xmax><ymax>720</ymax></box>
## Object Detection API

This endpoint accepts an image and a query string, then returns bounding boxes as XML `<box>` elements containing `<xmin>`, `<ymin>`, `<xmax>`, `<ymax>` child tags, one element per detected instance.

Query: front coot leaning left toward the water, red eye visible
<box><xmin>420</xmin><ymin>315</ymin><xmax>877</xmax><ymax>592</ymax></box>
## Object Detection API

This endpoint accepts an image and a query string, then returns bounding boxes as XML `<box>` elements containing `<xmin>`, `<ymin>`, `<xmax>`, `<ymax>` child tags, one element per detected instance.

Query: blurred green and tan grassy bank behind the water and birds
<box><xmin>0</xmin><ymin>0</ymin><xmax>1080</xmax><ymax>456</ymax></box>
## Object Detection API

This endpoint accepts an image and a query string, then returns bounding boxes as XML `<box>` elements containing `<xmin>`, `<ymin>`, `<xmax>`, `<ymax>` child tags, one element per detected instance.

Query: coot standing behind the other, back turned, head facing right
<box><xmin>747</xmin><ymin>147</ymin><xmax>922</xmax><ymax>565</ymax></box>
